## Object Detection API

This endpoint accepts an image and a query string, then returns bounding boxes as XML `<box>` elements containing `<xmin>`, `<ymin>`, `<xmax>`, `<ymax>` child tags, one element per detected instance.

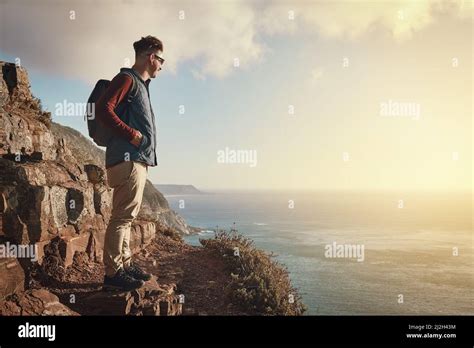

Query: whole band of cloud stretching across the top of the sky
<box><xmin>0</xmin><ymin>0</ymin><xmax>472</xmax><ymax>83</ymax></box>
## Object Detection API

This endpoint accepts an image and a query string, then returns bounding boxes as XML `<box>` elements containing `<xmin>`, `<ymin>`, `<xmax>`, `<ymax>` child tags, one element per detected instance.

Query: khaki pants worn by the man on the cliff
<box><xmin>104</xmin><ymin>161</ymin><xmax>148</xmax><ymax>276</ymax></box>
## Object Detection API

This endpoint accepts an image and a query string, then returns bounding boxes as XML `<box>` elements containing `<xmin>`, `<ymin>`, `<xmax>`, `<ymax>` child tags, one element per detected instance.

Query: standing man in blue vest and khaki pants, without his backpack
<box><xmin>96</xmin><ymin>36</ymin><xmax>164</xmax><ymax>290</ymax></box>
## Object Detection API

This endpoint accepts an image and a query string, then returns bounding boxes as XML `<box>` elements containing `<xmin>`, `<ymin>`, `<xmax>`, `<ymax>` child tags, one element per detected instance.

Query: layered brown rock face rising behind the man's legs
<box><xmin>0</xmin><ymin>62</ymin><xmax>191</xmax><ymax>312</ymax></box>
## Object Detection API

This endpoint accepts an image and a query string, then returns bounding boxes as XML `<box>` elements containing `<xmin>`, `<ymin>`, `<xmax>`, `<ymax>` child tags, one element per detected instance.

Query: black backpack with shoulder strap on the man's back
<box><xmin>84</xmin><ymin>72</ymin><xmax>137</xmax><ymax>146</ymax></box>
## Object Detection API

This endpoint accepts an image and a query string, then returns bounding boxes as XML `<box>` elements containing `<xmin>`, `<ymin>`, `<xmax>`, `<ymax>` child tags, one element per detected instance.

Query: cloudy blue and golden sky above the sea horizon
<box><xmin>0</xmin><ymin>0</ymin><xmax>473</xmax><ymax>191</ymax></box>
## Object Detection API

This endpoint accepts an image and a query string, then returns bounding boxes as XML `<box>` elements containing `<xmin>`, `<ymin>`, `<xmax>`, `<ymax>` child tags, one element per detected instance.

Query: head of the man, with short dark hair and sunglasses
<box><xmin>133</xmin><ymin>35</ymin><xmax>165</xmax><ymax>78</ymax></box>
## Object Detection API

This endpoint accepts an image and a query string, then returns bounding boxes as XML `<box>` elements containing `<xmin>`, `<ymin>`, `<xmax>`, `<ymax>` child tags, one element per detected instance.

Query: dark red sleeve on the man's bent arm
<box><xmin>95</xmin><ymin>74</ymin><xmax>136</xmax><ymax>141</ymax></box>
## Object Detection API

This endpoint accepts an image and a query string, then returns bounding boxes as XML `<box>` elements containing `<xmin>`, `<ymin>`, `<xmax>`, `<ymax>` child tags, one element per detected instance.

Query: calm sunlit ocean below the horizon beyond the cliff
<box><xmin>166</xmin><ymin>191</ymin><xmax>474</xmax><ymax>315</ymax></box>
